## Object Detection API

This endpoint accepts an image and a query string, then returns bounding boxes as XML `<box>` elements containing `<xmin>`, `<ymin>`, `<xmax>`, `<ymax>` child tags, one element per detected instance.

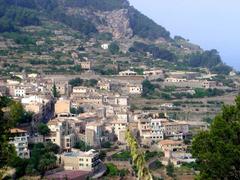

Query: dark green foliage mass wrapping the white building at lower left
<box><xmin>0</xmin><ymin>97</ymin><xmax>59</xmax><ymax>179</ymax></box>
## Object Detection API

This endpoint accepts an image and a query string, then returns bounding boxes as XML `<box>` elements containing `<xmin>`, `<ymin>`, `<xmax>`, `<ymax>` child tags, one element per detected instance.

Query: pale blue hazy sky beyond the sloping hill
<box><xmin>129</xmin><ymin>0</ymin><xmax>240</xmax><ymax>71</ymax></box>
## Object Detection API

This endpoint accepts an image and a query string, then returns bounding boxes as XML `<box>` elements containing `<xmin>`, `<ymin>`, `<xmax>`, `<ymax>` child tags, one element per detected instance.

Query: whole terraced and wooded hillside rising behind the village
<box><xmin>0</xmin><ymin>0</ymin><xmax>232</xmax><ymax>74</ymax></box>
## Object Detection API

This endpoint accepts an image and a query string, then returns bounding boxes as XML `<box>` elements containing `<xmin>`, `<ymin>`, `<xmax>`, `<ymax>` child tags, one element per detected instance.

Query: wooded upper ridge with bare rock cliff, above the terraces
<box><xmin>0</xmin><ymin>0</ymin><xmax>232</xmax><ymax>74</ymax></box>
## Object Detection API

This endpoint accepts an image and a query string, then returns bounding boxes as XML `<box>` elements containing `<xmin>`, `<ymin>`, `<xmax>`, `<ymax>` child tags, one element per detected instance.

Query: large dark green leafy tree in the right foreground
<box><xmin>192</xmin><ymin>96</ymin><xmax>240</xmax><ymax>180</ymax></box>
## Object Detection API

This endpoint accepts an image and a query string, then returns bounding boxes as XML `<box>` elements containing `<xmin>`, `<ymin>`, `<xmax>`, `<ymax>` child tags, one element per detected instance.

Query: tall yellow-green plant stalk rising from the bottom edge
<box><xmin>126</xmin><ymin>129</ymin><xmax>153</xmax><ymax>180</ymax></box>
